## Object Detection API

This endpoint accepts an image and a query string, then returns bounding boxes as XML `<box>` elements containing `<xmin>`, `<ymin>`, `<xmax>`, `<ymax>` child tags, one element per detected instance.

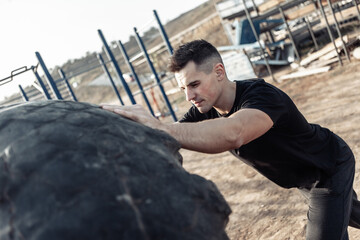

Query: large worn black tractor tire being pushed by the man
<box><xmin>0</xmin><ymin>101</ymin><xmax>231</xmax><ymax>240</ymax></box>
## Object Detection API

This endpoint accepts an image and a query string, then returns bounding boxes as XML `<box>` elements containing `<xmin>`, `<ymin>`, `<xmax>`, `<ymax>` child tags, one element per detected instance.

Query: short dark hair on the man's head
<box><xmin>169</xmin><ymin>39</ymin><xmax>223</xmax><ymax>72</ymax></box>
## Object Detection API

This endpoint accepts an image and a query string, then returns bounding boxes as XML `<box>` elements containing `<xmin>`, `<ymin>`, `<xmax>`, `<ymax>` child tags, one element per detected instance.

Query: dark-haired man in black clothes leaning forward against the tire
<box><xmin>102</xmin><ymin>40</ymin><xmax>360</xmax><ymax>240</ymax></box>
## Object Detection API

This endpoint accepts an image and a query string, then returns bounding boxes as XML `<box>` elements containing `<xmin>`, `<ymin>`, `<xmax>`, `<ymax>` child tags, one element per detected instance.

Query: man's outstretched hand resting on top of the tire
<box><xmin>100</xmin><ymin>104</ymin><xmax>162</xmax><ymax>129</ymax></box>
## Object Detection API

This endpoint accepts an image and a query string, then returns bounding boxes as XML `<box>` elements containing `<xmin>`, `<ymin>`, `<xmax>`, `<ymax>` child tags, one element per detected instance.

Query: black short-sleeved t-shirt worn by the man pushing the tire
<box><xmin>179</xmin><ymin>79</ymin><xmax>339</xmax><ymax>188</ymax></box>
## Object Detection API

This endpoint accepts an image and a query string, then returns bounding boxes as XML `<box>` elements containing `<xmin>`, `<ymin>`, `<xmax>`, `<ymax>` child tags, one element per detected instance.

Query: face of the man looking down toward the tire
<box><xmin>175</xmin><ymin>61</ymin><xmax>220</xmax><ymax>113</ymax></box>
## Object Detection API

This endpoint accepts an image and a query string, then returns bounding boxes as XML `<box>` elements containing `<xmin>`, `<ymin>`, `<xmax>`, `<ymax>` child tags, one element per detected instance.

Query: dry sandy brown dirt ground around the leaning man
<box><xmin>181</xmin><ymin>58</ymin><xmax>360</xmax><ymax>240</ymax></box>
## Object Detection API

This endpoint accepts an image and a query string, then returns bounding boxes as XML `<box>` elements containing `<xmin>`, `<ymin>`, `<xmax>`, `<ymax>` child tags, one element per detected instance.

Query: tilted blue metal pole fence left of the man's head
<box><xmin>0</xmin><ymin>10</ymin><xmax>177</xmax><ymax>121</ymax></box>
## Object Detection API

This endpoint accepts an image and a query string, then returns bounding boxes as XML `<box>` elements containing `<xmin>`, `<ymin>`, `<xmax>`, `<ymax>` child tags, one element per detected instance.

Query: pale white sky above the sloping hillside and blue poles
<box><xmin>0</xmin><ymin>0</ymin><xmax>207</xmax><ymax>100</ymax></box>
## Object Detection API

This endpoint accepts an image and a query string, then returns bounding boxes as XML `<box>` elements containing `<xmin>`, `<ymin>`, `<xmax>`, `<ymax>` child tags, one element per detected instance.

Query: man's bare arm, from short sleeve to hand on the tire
<box><xmin>102</xmin><ymin>105</ymin><xmax>273</xmax><ymax>153</ymax></box>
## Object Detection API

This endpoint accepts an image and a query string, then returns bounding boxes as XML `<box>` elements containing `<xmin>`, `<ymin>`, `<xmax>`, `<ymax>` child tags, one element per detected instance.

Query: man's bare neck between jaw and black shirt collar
<box><xmin>214</xmin><ymin>80</ymin><xmax>236</xmax><ymax>115</ymax></box>
